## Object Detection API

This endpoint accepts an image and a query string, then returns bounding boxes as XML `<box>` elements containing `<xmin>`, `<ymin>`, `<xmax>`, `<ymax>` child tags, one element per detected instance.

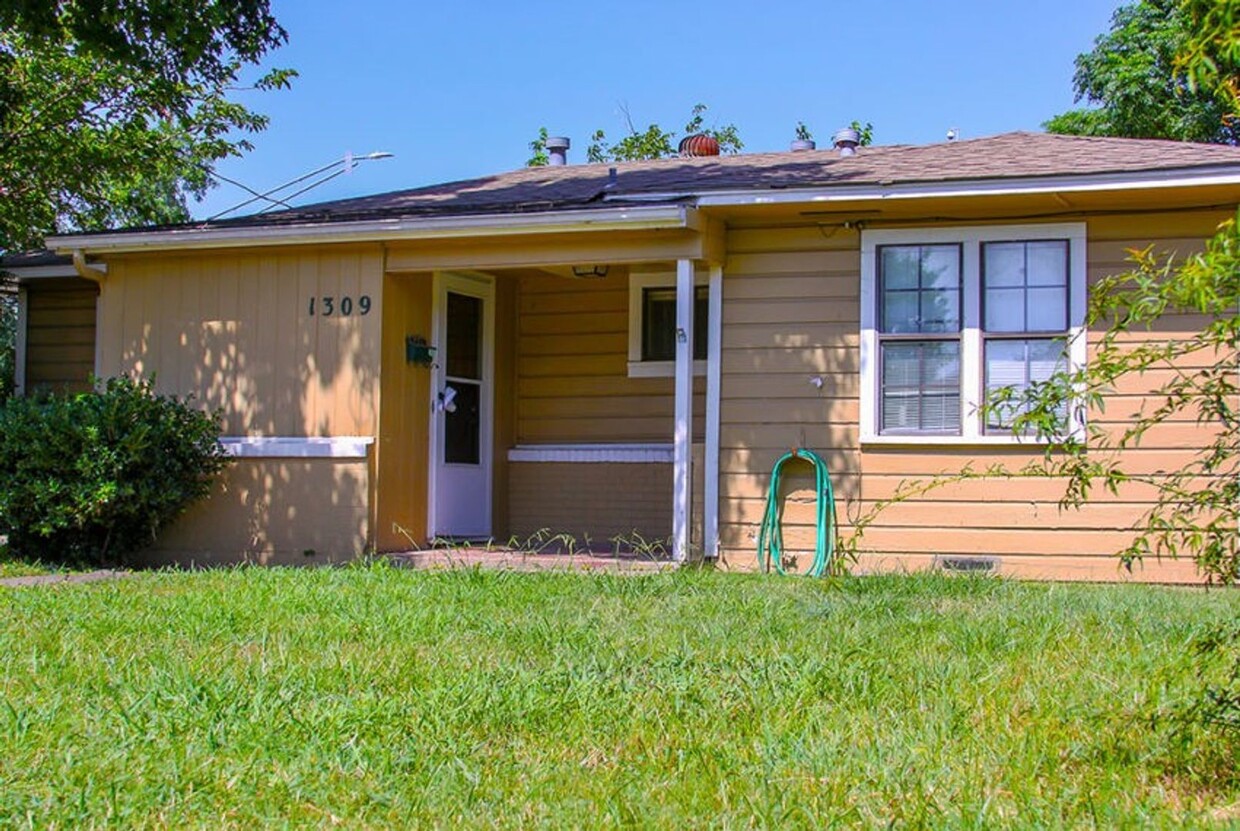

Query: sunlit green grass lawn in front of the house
<box><xmin>0</xmin><ymin>566</ymin><xmax>1240</xmax><ymax>827</ymax></box>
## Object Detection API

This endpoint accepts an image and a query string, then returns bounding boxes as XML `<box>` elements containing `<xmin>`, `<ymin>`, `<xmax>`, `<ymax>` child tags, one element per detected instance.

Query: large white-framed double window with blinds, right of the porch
<box><xmin>861</xmin><ymin>223</ymin><xmax>1085</xmax><ymax>443</ymax></box>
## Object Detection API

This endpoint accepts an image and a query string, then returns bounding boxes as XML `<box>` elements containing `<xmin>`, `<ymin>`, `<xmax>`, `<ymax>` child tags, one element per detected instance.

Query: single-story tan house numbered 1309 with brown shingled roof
<box><xmin>5</xmin><ymin>133</ymin><xmax>1240</xmax><ymax>580</ymax></box>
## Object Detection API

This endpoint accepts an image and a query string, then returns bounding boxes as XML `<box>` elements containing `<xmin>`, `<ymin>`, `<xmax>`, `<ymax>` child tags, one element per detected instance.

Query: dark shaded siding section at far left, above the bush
<box><xmin>25</xmin><ymin>279</ymin><xmax>99</xmax><ymax>393</ymax></box>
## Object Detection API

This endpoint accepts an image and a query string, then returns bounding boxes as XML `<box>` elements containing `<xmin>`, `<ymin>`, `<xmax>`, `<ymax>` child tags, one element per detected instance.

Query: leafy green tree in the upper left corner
<box><xmin>0</xmin><ymin>0</ymin><xmax>296</xmax><ymax>251</ymax></box>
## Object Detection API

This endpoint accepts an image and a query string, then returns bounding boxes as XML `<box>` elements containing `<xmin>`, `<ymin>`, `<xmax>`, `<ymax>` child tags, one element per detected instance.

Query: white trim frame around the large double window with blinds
<box><xmin>859</xmin><ymin>222</ymin><xmax>1086</xmax><ymax>445</ymax></box>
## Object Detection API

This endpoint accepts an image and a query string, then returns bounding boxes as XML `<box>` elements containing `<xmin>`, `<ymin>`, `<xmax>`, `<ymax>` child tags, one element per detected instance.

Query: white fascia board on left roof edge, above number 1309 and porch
<box><xmin>47</xmin><ymin>205</ymin><xmax>696</xmax><ymax>254</ymax></box>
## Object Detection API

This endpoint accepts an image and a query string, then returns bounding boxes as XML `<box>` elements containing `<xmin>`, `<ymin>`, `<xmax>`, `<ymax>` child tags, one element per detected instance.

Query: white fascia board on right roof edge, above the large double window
<box><xmin>620</xmin><ymin>165</ymin><xmax>1240</xmax><ymax>207</ymax></box>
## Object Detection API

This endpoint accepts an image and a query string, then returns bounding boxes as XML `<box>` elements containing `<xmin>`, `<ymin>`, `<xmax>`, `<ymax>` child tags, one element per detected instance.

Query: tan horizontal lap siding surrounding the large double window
<box><xmin>719</xmin><ymin>212</ymin><xmax>1225</xmax><ymax>580</ymax></box>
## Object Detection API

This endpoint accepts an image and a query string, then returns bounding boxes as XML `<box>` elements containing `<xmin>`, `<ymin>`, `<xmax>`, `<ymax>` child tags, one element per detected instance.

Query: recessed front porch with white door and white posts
<box><xmin>373</xmin><ymin>214</ymin><xmax>723</xmax><ymax>562</ymax></box>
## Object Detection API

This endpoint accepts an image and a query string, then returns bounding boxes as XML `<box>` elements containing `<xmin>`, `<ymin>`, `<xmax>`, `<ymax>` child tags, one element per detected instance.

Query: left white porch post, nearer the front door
<box><xmin>672</xmin><ymin>259</ymin><xmax>693</xmax><ymax>563</ymax></box>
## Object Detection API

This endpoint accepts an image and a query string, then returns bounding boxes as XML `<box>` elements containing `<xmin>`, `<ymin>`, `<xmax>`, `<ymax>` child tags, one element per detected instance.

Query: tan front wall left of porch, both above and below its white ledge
<box><xmin>99</xmin><ymin>246</ymin><xmax>383</xmax><ymax>562</ymax></box>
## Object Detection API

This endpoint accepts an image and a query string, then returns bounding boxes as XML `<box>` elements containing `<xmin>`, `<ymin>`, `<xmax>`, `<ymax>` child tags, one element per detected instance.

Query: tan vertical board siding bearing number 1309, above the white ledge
<box><xmin>99</xmin><ymin>246</ymin><xmax>383</xmax><ymax>437</ymax></box>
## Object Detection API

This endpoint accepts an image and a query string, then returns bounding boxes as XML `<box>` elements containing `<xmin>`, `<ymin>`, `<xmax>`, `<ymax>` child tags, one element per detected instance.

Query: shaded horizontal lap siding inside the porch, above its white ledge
<box><xmin>516</xmin><ymin>268</ymin><xmax>706</xmax><ymax>444</ymax></box>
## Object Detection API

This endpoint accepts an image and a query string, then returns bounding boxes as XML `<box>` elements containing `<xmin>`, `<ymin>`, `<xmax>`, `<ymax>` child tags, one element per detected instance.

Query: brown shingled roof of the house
<box><xmin>159</xmin><ymin>133</ymin><xmax>1240</xmax><ymax>227</ymax></box>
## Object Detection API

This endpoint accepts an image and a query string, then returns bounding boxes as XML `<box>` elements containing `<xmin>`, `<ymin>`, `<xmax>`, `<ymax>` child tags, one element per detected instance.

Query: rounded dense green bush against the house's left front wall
<box><xmin>0</xmin><ymin>378</ymin><xmax>228</xmax><ymax>564</ymax></box>
